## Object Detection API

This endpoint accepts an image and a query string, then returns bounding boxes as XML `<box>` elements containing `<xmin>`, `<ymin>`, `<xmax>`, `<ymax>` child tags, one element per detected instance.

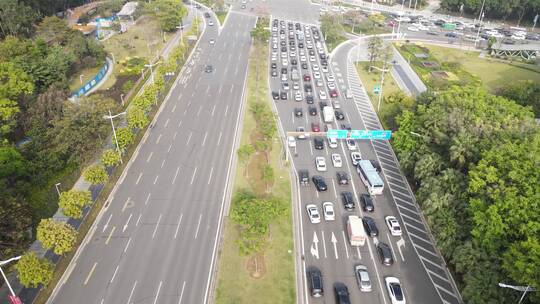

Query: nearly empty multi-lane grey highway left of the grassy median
<box><xmin>49</xmin><ymin>5</ymin><xmax>256</xmax><ymax>304</ymax></box>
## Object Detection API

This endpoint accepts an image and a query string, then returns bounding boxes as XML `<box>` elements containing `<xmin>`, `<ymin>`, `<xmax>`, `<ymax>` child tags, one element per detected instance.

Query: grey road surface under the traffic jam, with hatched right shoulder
<box><xmin>269</xmin><ymin>1</ymin><xmax>460</xmax><ymax>304</ymax></box>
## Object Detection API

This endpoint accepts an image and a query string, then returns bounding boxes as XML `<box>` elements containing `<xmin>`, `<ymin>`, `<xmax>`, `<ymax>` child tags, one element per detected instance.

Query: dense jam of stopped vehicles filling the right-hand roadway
<box><xmin>270</xmin><ymin>19</ymin><xmax>405</xmax><ymax>304</ymax></box>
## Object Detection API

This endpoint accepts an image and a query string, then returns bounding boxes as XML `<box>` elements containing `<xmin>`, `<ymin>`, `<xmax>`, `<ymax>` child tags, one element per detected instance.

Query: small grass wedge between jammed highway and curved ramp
<box><xmin>356</xmin><ymin>61</ymin><xmax>401</xmax><ymax>112</ymax></box>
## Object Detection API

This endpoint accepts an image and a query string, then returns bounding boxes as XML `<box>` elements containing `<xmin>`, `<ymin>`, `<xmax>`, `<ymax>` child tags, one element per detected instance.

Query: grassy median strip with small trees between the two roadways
<box><xmin>216</xmin><ymin>40</ymin><xmax>296</xmax><ymax>304</ymax></box>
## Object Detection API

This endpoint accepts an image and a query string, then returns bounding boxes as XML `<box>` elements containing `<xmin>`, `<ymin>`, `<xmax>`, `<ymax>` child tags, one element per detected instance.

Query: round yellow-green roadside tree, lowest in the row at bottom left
<box><xmin>15</xmin><ymin>251</ymin><xmax>54</xmax><ymax>287</ymax></box>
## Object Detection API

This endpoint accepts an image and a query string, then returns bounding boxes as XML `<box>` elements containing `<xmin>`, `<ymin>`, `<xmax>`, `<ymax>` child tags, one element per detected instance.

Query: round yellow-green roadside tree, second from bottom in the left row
<box><xmin>36</xmin><ymin>218</ymin><xmax>77</xmax><ymax>255</ymax></box>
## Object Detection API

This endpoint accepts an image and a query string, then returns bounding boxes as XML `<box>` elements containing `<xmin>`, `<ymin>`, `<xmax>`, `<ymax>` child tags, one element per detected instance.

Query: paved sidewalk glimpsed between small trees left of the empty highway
<box><xmin>0</xmin><ymin>6</ymin><xmax>198</xmax><ymax>304</ymax></box>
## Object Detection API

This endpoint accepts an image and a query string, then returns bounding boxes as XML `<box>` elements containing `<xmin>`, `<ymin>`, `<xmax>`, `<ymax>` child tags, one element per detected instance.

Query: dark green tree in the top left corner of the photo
<box><xmin>0</xmin><ymin>0</ymin><xmax>38</xmax><ymax>38</ymax></box>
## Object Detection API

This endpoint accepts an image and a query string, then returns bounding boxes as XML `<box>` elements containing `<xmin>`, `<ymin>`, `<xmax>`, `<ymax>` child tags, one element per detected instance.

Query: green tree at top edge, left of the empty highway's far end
<box><xmin>145</xmin><ymin>0</ymin><xmax>187</xmax><ymax>32</ymax></box>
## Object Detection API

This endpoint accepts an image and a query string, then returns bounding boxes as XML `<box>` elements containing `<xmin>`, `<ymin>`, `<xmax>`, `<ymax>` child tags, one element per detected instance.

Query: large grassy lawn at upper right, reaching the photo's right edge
<box><xmin>396</xmin><ymin>43</ymin><xmax>540</xmax><ymax>93</ymax></box>
